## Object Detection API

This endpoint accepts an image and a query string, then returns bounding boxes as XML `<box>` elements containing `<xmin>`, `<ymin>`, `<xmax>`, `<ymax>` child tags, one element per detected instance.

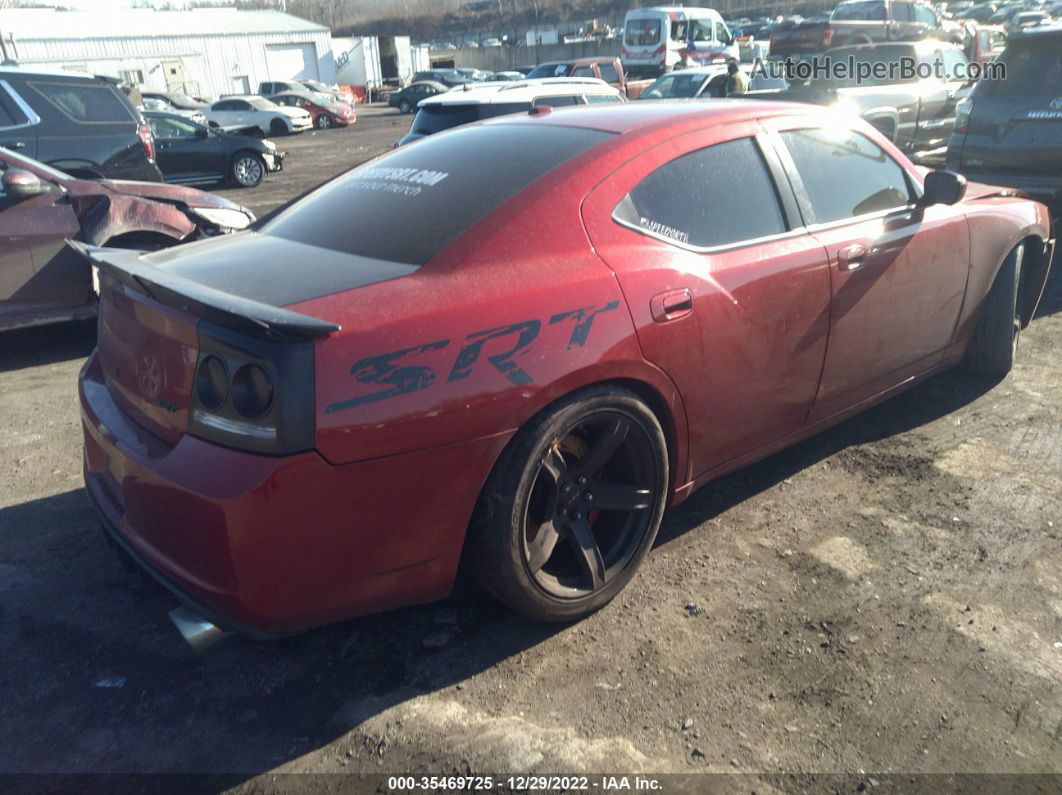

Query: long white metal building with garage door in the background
<box><xmin>0</xmin><ymin>8</ymin><xmax>336</xmax><ymax>97</ymax></box>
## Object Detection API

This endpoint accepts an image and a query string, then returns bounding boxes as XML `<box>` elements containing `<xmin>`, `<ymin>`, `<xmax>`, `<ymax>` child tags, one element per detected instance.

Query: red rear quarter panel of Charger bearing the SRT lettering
<box><xmin>292</xmin><ymin>162</ymin><xmax>685</xmax><ymax>478</ymax></box>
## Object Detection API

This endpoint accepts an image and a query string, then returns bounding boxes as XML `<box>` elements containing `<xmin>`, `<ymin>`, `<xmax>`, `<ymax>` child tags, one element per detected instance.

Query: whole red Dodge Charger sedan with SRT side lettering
<box><xmin>80</xmin><ymin>100</ymin><xmax>1054</xmax><ymax>636</ymax></box>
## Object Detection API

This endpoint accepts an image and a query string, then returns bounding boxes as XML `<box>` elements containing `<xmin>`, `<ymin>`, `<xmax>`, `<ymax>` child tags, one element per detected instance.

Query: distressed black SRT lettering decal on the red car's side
<box><xmin>325</xmin><ymin>300</ymin><xmax>619</xmax><ymax>414</ymax></box>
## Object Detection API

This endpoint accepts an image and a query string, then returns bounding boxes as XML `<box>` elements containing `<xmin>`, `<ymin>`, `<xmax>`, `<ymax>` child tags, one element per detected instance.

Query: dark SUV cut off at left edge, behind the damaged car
<box><xmin>0</xmin><ymin>67</ymin><xmax>162</xmax><ymax>182</ymax></box>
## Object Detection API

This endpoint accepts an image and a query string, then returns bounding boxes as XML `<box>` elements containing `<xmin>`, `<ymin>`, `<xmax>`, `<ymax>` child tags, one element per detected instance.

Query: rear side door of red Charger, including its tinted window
<box><xmin>583</xmin><ymin>122</ymin><xmax>829</xmax><ymax>478</ymax></box>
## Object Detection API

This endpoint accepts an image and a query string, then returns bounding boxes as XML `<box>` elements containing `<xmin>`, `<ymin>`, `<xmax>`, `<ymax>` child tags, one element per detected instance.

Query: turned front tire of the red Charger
<box><xmin>962</xmin><ymin>244</ymin><xmax>1025</xmax><ymax>378</ymax></box>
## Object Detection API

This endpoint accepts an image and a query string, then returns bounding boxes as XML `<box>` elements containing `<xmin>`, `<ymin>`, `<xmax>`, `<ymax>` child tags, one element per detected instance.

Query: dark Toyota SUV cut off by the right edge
<box><xmin>947</xmin><ymin>25</ymin><xmax>1062</xmax><ymax>211</ymax></box>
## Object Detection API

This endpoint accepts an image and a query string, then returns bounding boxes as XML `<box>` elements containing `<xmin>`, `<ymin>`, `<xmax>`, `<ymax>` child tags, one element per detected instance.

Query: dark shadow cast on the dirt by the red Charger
<box><xmin>0</xmin><ymin>356</ymin><xmax>1006</xmax><ymax>787</ymax></box>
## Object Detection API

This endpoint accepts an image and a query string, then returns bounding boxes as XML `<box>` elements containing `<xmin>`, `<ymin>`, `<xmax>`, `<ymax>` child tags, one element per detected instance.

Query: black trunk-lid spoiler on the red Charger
<box><xmin>67</xmin><ymin>240</ymin><xmax>340</xmax><ymax>340</ymax></box>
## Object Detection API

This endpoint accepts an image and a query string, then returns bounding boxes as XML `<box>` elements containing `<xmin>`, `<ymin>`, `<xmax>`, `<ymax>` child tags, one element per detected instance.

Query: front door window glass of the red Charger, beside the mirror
<box><xmin>782</xmin><ymin>127</ymin><xmax>910</xmax><ymax>224</ymax></box>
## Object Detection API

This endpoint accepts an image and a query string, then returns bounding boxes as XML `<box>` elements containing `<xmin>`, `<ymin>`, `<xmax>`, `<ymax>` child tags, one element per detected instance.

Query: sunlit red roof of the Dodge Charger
<box><xmin>482</xmin><ymin>99</ymin><xmax>836</xmax><ymax>136</ymax></box>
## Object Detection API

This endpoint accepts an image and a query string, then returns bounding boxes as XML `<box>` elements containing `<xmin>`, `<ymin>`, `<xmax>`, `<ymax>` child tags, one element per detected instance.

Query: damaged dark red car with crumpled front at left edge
<box><xmin>0</xmin><ymin>148</ymin><xmax>254</xmax><ymax>331</ymax></box>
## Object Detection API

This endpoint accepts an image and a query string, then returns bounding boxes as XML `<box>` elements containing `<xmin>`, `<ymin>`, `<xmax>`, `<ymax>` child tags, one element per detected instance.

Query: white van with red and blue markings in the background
<box><xmin>619</xmin><ymin>5</ymin><xmax>738</xmax><ymax>77</ymax></box>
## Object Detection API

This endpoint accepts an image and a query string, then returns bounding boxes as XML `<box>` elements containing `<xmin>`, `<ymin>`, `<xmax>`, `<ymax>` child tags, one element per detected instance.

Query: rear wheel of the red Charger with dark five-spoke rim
<box><xmin>465</xmin><ymin>386</ymin><xmax>668</xmax><ymax>622</ymax></box>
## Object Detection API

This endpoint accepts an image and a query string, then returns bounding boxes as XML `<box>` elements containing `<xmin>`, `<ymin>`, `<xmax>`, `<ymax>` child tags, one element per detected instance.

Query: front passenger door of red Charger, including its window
<box><xmin>777</xmin><ymin>125</ymin><xmax>970</xmax><ymax>421</ymax></box>
